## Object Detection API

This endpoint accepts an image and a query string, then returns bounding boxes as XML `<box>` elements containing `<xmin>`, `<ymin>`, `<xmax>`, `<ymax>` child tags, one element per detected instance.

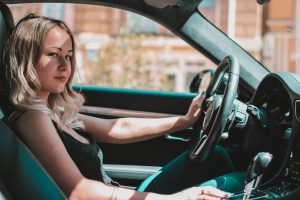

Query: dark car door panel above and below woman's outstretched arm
<box><xmin>75</xmin><ymin>86</ymin><xmax>196</xmax><ymax>166</ymax></box>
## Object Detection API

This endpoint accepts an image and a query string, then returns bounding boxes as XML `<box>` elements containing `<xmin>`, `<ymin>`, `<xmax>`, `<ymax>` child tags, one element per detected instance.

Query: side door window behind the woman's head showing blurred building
<box><xmin>10</xmin><ymin>3</ymin><xmax>215</xmax><ymax>92</ymax></box>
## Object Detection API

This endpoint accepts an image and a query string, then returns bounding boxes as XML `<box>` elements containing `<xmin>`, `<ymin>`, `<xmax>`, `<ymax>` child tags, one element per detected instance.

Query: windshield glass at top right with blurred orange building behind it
<box><xmin>199</xmin><ymin>0</ymin><xmax>300</xmax><ymax>73</ymax></box>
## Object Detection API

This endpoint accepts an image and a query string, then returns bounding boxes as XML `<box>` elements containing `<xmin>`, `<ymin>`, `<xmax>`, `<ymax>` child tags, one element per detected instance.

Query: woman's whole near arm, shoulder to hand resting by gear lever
<box><xmin>15</xmin><ymin>111</ymin><xmax>225</xmax><ymax>200</ymax></box>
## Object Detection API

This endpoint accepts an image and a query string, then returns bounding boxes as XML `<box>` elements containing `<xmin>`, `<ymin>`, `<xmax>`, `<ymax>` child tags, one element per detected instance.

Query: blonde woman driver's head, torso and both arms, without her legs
<box><xmin>4</xmin><ymin>14</ymin><xmax>230</xmax><ymax>200</ymax></box>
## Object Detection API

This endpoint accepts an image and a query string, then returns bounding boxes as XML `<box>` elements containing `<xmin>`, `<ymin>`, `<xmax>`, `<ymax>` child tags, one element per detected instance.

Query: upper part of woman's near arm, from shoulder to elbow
<box><xmin>15</xmin><ymin>111</ymin><xmax>83</xmax><ymax>195</ymax></box>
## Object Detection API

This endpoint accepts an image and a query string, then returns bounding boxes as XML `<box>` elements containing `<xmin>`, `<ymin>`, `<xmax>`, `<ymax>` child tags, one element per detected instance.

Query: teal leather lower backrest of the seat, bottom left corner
<box><xmin>0</xmin><ymin>120</ymin><xmax>65</xmax><ymax>200</ymax></box>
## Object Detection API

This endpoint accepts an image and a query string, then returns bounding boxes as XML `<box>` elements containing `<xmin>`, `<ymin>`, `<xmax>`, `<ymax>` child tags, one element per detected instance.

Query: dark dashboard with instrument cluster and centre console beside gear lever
<box><xmin>250</xmin><ymin>72</ymin><xmax>300</xmax><ymax>198</ymax></box>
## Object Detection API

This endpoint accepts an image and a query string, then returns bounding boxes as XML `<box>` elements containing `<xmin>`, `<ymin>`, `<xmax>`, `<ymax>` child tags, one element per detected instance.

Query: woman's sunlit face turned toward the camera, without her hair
<box><xmin>35</xmin><ymin>26</ymin><xmax>73</xmax><ymax>101</ymax></box>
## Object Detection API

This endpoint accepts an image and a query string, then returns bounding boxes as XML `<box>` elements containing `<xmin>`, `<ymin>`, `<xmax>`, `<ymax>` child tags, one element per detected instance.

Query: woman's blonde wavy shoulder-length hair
<box><xmin>4</xmin><ymin>14</ymin><xmax>84</xmax><ymax>128</ymax></box>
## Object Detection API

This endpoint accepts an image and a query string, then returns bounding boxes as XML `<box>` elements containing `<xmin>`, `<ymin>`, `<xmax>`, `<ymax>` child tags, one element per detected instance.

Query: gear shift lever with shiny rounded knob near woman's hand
<box><xmin>243</xmin><ymin>152</ymin><xmax>273</xmax><ymax>200</ymax></box>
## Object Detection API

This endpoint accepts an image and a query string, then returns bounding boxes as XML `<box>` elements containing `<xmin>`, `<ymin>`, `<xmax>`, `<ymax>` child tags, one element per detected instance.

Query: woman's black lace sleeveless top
<box><xmin>53</xmin><ymin>122</ymin><xmax>118</xmax><ymax>185</ymax></box>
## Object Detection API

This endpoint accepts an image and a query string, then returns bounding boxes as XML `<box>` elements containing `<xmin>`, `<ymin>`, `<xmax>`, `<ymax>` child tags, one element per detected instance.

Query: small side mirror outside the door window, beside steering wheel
<box><xmin>190</xmin><ymin>69</ymin><xmax>215</xmax><ymax>93</ymax></box>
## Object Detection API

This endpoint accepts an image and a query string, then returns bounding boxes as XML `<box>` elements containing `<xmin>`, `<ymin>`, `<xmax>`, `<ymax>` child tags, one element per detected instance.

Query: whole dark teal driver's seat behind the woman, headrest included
<box><xmin>0</xmin><ymin>1</ymin><xmax>66</xmax><ymax>200</ymax></box>
